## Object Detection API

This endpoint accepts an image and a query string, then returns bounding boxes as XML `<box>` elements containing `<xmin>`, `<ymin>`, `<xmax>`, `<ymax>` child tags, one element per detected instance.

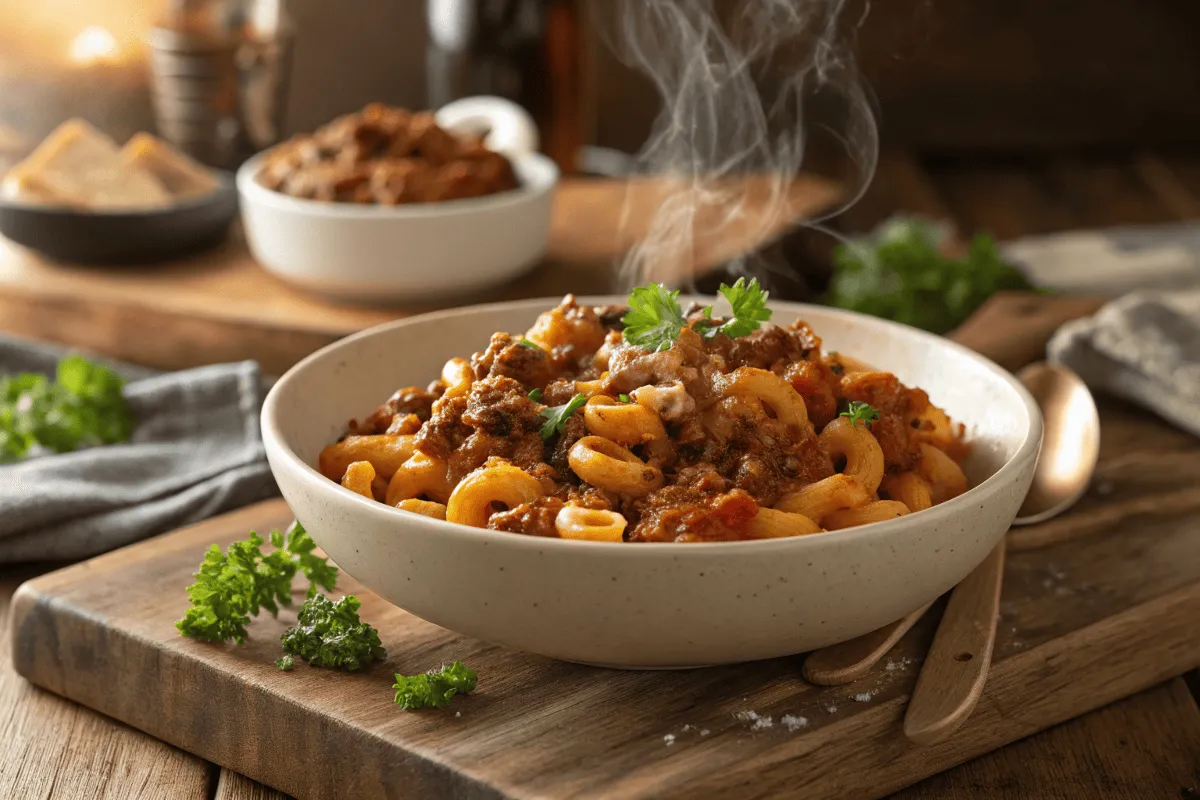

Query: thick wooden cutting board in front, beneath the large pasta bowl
<box><xmin>4</xmin><ymin>296</ymin><xmax>1200</xmax><ymax>799</ymax></box>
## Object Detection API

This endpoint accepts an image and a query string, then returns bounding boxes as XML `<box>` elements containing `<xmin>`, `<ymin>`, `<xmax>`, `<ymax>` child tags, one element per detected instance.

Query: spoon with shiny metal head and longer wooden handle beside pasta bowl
<box><xmin>904</xmin><ymin>363</ymin><xmax>1100</xmax><ymax>745</ymax></box>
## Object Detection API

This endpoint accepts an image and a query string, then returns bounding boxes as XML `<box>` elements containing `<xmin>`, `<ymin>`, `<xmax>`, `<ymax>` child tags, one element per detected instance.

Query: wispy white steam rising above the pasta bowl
<box><xmin>593</xmin><ymin>0</ymin><xmax>878</xmax><ymax>288</ymax></box>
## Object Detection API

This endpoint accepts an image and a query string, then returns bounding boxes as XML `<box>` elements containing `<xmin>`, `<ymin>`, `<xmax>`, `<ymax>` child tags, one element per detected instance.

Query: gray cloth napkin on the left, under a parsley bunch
<box><xmin>0</xmin><ymin>337</ymin><xmax>278</xmax><ymax>564</ymax></box>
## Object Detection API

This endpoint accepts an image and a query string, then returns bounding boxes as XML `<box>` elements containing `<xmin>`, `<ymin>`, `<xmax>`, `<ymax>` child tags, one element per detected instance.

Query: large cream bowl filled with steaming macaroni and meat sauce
<box><xmin>263</xmin><ymin>281</ymin><xmax>1042</xmax><ymax>667</ymax></box>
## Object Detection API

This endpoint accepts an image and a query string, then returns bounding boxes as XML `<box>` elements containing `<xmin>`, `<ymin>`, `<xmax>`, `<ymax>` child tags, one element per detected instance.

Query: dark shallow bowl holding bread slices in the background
<box><xmin>0</xmin><ymin>173</ymin><xmax>238</xmax><ymax>264</ymax></box>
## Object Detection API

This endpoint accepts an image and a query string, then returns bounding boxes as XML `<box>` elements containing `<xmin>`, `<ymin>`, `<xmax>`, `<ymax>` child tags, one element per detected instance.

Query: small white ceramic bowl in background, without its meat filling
<box><xmin>238</xmin><ymin>97</ymin><xmax>558</xmax><ymax>302</ymax></box>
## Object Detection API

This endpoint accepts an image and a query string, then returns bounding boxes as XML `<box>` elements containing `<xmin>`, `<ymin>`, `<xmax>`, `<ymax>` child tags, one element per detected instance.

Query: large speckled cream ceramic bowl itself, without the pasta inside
<box><xmin>263</xmin><ymin>297</ymin><xmax>1042</xmax><ymax>667</ymax></box>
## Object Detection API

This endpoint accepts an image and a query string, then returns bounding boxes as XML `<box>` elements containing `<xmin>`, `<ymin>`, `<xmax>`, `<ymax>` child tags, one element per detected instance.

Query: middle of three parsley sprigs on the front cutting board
<box><xmin>280</xmin><ymin>595</ymin><xmax>388</xmax><ymax>672</ymax></box>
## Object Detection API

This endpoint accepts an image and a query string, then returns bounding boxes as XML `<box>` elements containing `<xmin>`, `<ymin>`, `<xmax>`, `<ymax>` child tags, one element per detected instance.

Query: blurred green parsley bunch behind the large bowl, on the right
<box><xmin>826</xmin><ymin>218</ymin><xmax>1032</xmax><ymax>333</ymax></box>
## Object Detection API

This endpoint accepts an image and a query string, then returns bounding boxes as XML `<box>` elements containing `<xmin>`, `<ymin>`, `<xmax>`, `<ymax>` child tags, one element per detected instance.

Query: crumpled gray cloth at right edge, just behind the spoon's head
<box><xmin>1048</xmin><ymin>289</ymin><xmax>1200</xmax><ymax>437</ymax></box>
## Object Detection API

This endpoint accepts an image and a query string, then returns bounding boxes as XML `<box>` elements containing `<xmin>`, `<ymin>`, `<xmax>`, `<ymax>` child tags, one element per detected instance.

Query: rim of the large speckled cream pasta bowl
<box><xmin>262</xmin><ymin>295</ymin><xmax>1042</xmax><ymax>558</ymax></box>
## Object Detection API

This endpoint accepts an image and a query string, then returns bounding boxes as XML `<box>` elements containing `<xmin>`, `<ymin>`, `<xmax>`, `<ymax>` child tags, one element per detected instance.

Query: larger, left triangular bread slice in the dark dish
<box><xmin>4</xmin><ymin>120</ymin><xmax>172</xmax><ymax>210</ymax></box>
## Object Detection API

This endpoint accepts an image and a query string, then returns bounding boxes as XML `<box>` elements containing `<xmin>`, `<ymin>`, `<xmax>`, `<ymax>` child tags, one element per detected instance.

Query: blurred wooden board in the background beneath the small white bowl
<box><xmin>0</xmin><ymin>176</ymin><xmax>841</xmax><ymax>375</ymax></box>
